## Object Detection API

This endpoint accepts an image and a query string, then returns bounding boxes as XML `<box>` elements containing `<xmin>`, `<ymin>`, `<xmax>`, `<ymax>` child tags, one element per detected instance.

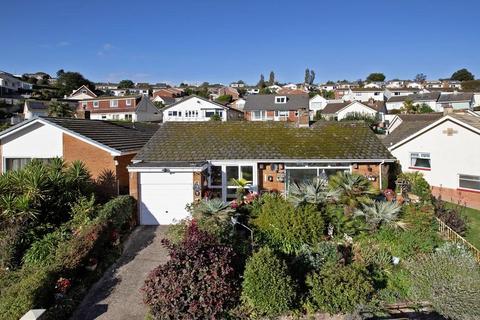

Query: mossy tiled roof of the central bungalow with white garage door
<box><xmin>134</xmin><ymin>121</ymin><xmax>393</xmax><ymax>166</ymax></box>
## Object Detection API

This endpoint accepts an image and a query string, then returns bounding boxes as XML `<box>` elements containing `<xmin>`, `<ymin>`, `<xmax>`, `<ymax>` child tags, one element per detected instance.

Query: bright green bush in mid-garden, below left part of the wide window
<box><xmin>252</xmin><ymin>194</ymin><xmax>325</xmax><ymax>254</ymax></box>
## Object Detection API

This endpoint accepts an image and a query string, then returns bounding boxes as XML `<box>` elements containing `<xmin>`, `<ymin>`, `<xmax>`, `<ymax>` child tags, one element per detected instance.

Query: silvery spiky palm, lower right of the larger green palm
<box><xmin>354</xmin><ymin>201</ymin><xmax>405</xmax><ymax>230</ymax></box>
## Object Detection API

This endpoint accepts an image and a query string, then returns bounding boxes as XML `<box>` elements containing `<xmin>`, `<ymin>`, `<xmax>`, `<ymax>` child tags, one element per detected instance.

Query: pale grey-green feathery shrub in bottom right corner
<box><xmin>407</xmin><ymin>243</ymin><xmax>480</xmax><ymax>320</ymax></box>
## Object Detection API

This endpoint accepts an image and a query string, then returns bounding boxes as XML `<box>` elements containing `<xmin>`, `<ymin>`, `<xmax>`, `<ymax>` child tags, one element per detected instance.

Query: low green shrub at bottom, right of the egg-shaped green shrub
<box><xmin>307</xmin><ymin>264</ymin><xmax>374</xmax><ymax>314</ymax></box>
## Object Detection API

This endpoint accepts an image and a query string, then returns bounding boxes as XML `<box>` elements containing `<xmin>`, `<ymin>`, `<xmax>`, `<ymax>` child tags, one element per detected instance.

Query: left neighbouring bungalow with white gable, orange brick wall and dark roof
<box><xmin>0</xmin><ymin>117</ymin><xmax>153</xmax><ymax>193</ymax></box>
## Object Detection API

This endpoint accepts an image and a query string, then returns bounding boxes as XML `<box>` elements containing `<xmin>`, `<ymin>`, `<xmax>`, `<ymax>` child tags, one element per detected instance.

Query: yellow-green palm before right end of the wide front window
<box><xmin>329</xmin><ymin>171</ymin><xmax>375</xmax><ymax>214</ymax></box>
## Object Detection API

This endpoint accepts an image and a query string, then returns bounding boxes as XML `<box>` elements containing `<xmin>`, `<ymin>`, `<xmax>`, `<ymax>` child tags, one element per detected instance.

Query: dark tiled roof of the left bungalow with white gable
<box><xmin>42</xmin><ymin>117</ymin><xmax>153</xmax><ymax>152</ymax></box>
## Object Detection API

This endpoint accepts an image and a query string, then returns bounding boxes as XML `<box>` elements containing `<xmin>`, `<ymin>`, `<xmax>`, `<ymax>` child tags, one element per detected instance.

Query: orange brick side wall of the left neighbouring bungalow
<box><xmin>63</xmin><ymin>133</ymin><xmax>116</xmax><ymax>179</ymax></box>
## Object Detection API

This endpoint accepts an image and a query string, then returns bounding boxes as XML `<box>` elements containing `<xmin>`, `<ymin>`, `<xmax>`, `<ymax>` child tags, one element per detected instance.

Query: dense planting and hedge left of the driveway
<box><xmin>0</xmin><ymin>159</ymin><xmax>135</xmax><ymax>320</ymax></box>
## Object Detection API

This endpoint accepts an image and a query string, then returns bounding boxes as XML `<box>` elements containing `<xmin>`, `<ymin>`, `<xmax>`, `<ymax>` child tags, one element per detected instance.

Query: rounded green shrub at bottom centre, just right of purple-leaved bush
<box><xmin>242</xmin><ymin>247</ymin><xmax>295</xmax><ymax>316</ymax></box>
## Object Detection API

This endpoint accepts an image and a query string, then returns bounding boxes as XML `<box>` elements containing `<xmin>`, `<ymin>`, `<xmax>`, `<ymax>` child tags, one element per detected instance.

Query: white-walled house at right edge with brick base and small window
<box><xmin>383</xmin><ymin>108</ymin><xmax>480</xmax><ymax>209</ymax></box>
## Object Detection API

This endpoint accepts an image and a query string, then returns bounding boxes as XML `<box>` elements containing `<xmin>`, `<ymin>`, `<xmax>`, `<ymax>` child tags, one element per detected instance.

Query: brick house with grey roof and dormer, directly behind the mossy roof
<box><xmin>243</xmin><ymin>94</ymin><xmax>309</xmax><ymax>122</ymax></box>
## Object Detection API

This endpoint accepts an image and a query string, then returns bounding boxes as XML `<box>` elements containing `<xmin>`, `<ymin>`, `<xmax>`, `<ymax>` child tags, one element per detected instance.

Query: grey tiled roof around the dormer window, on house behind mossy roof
<box><xmin>244</xmin><ymin>94</ymin><xmax>310</xmax><ymax>111</ymax></box>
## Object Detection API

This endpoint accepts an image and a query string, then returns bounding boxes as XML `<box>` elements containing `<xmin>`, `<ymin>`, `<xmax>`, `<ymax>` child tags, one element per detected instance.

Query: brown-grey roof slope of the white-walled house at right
<box><xmin>382</xmin><ymin>113</ymin><xmax>443</xmax><ymax>147</ymax></box>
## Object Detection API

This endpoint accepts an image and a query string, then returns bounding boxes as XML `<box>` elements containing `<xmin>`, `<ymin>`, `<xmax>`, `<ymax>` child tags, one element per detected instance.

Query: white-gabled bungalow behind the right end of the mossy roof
<box><xmin>321</xmin><ymin>101</ymin><xmax>385</xmax><ymax>121</ymax></box>
